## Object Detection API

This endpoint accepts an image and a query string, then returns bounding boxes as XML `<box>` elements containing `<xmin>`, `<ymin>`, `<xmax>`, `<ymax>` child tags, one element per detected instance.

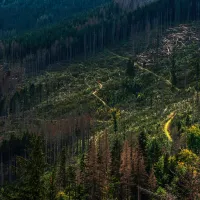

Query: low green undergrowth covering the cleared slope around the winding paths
<box><xmin>2</xmin><ymin>25</ymin><xmax>198</xmax><ymax>142</ymax></box>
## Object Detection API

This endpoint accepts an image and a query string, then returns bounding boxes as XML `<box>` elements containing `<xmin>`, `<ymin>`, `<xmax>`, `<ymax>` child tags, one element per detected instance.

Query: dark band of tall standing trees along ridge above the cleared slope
<box><xmin>0</xmin><ymin>0</ymin><xmax>200</xmax><ymax>73</ymax></box>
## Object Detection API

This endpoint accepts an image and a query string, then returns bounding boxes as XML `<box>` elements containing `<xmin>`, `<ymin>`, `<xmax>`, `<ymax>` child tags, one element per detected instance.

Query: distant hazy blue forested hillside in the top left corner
<box><xmin>0</xmin><ymin>0</ymin><xmax>107</xmax><ymax>34</ymax></box>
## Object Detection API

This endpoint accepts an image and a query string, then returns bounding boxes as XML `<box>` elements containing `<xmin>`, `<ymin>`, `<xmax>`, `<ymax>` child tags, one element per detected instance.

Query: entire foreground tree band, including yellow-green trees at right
<box><xmin>1</xmin><ymin>131</ymin><xmax>199</xmax><ymax>200</ymax></box>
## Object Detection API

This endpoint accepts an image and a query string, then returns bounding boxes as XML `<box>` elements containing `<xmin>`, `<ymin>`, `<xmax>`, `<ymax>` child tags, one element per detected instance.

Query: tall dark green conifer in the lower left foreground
<box><xmin>17</xmin><ymin>135</ymin><xmax>46</xmax><ymax>200</ymax></box>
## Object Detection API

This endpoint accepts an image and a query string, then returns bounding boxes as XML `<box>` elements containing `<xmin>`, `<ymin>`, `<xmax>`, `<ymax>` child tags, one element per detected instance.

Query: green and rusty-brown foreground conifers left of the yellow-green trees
<box><xmin>0</xmin><ymin>132</ymin><xmax>160</xmax><ymax>200</ymax></box>
